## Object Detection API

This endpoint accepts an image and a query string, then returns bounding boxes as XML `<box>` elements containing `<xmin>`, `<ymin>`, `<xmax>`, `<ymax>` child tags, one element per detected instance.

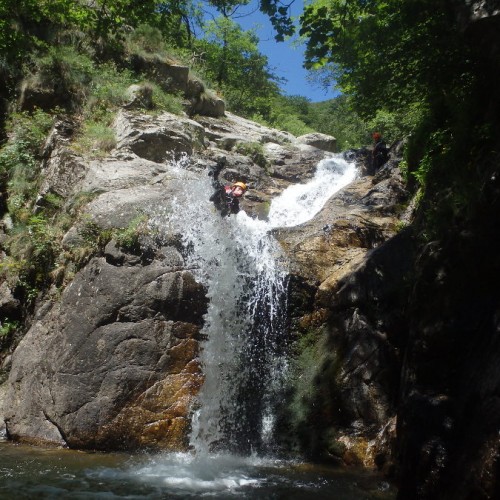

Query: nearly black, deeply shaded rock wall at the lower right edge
<box><xmin>397</xmin><ymin>225</ymin><xmax>500</xmax><ymax>499</ymax></box>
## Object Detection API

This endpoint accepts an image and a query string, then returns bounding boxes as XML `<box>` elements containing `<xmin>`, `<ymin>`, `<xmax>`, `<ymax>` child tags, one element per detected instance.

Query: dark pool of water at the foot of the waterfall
<box><xmin>0</xmin><ymin>442</ymin><xmax>395</xmax><ymax>500</ymax></box>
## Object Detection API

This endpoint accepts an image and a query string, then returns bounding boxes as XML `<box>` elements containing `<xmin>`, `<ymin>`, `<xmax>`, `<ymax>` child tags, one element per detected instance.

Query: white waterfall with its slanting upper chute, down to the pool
<box><xmin>157</xmin><ymin>156</ymin><xmax>355</xmax><ymax>455</ymax></box>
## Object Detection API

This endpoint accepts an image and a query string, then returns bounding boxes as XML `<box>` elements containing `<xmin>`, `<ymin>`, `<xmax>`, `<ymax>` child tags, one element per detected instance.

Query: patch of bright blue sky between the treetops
<box><xmin>205</xmin><ymin>0</ymin><xmax>338</xmax><ymax>102</ymax></box>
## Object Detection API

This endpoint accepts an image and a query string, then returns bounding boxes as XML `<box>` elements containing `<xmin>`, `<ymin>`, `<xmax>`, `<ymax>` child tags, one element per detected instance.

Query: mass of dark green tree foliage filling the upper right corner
<box><xmin>301</xmin><ymin>0</ymin><xmax>500</xmax><ymax>250</ymax></box>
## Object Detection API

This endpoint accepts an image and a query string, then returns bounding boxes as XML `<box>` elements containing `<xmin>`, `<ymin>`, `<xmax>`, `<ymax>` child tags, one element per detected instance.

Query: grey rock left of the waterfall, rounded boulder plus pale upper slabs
<box><xmin>0</xmin><ymin>101</ymin><xmax>338</xmax><ymax>450</ymax></box>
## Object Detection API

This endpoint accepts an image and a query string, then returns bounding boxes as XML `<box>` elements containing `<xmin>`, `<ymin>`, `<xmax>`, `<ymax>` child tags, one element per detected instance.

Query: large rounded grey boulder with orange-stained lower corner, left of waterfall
<box><xmin>4</xmin><ymin>244</ymin><xmax>206</xmax><ymax>450</ymax></box>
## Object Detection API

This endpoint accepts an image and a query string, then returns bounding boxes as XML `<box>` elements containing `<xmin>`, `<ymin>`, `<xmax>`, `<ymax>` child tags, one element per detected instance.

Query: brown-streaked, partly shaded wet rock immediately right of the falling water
<box><xmin>277</xmin><ymin>152</ymin><xmax>415</xmax><ymax>468</ymax></box>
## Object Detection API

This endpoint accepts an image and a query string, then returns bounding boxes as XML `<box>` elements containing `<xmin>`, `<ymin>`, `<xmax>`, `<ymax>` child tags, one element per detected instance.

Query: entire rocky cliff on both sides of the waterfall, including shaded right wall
<box><xmin>0</xmin><ymin>68</ymin><xmax>500</xmax><ymax>498</ymax></box>
